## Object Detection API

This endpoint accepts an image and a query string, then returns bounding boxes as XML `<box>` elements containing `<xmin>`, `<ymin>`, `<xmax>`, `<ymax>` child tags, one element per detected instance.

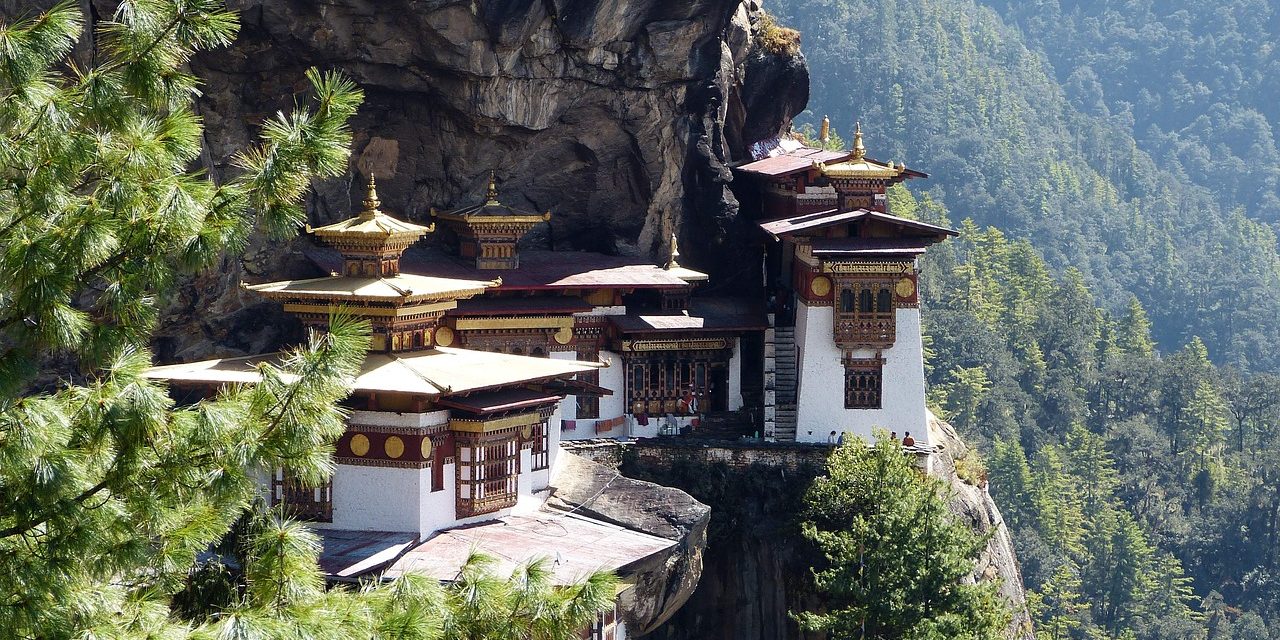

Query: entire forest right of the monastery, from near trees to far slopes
<box><xmin>771</xmin><ymin>0</ymin><xmax>1280</xmax><ymax>640</ymax></box>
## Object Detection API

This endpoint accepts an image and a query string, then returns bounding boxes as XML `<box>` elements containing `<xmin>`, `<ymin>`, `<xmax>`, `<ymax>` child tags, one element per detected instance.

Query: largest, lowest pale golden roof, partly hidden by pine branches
<box><xmin>143</xmin><ymin>347</ymin><xmax>605</xmax><ymax>396</ymax></box>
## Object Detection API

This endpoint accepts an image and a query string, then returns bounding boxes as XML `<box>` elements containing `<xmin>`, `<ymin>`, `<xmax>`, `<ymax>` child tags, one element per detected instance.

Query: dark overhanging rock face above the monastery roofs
<box><xmin>122</xmin><ymin>0</ymin><xmax>808</xmax><ymax>360</ymax></box>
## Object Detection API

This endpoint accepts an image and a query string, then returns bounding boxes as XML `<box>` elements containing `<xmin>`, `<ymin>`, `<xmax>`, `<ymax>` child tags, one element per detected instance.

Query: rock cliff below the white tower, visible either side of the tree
<box><xmin>621</xmin><ymin>430</ymin><xmax>1034</xmax><ymax>640</ymax></box>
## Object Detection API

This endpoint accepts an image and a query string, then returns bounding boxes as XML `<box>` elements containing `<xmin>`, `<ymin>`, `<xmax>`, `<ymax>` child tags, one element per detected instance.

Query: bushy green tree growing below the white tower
<box><xmin>796</xmin><ymin>433</ymin><xmax>1010</xmax><ymax>640</ymax></box>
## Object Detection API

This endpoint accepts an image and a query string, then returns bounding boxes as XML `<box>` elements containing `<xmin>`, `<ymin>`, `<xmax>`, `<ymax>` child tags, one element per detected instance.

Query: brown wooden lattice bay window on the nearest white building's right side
<box><xmin>454</xmin><ymin>429</ymin><xmax>520</xmax><ymax>517</ymax></box>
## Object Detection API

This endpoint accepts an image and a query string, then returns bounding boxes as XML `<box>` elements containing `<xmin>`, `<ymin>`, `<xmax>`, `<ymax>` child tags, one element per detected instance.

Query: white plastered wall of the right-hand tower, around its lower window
<box><xmin>796</xmin><ymin>302</ymin><xmax>929</xmax><ymax>444</ymax></box>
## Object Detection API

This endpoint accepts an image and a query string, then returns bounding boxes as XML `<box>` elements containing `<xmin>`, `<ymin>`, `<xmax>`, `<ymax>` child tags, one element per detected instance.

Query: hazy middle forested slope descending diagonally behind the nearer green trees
<box><xmin>769</xmin><ymin>0</ymin><xmax>1280</xmax><ymax>370</ymax></box>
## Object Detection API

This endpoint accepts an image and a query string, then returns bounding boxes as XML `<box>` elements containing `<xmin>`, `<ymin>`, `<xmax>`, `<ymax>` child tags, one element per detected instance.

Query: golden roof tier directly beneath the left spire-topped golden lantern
<box><xmin>244</xmin><ymin>274</ymin><xmax>502</xmax><ymax>303</ymax></box>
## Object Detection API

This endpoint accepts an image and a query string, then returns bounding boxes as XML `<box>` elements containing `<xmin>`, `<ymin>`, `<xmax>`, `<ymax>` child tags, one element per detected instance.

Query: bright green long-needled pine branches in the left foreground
<box><xmin>0</xmin><ymin>0</ymin><xmax>613</xmax><ymax>640</ymax></box>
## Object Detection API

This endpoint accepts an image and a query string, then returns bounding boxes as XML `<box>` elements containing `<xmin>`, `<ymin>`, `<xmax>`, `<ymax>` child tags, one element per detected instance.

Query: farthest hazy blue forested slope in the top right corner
<box><xmin>986</xmin><ymin>0</ymin><xmax>1280</xmax><ymax>225</ymax></box>
